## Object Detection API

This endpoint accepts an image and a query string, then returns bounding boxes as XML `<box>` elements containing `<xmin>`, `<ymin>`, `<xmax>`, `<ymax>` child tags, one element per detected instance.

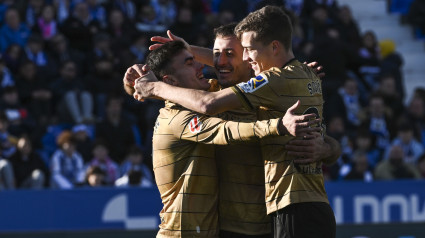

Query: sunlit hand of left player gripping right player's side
<box><xmin>279</xmin><ymin>100</ymin><xmax>322</xmax><ymax>137</ymax></box>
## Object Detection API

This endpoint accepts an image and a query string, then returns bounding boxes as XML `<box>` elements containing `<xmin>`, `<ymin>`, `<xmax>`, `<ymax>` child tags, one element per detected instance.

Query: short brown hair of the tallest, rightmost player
<box><xmin>235</xmin><ymin>6</ymin><xmax>292</xmax><ymax>50</ymax></box>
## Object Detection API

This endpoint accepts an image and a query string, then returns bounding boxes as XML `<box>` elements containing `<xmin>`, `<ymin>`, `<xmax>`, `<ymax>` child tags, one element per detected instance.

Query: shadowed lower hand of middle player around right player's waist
<box><xmin>285</xmin><ymin>132</ymin><xmax>331</xmax><ymax>164</ymax></box>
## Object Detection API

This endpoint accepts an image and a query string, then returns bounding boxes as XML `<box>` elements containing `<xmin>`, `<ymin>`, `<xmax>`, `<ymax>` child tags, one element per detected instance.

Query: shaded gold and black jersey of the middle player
<box><xmin>216</xmin><ymin>109</ymin><xmax>271</xmax><ymax>235</ymax></box>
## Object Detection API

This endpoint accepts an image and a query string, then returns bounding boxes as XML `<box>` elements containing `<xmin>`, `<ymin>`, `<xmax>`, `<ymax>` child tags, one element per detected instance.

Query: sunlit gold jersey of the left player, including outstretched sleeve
<box><xmin>153</xmin><ymin>102</ymin><xmax>278</xmax><ymax>237</ymax></box>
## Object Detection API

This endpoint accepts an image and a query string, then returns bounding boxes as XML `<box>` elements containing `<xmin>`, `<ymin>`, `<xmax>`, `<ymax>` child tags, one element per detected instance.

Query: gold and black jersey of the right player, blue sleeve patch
<box><xmin>232</xmin><ymin>60</ymin><xmax>328</xmax><ymax>214</ymax></box>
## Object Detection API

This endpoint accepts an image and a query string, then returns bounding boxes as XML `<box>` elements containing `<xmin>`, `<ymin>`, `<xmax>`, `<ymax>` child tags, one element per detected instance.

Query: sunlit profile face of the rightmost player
<box><xmin>241</xmin><ymin>31</ymin><xmax>274</xmax><ymax>75</ymax></box>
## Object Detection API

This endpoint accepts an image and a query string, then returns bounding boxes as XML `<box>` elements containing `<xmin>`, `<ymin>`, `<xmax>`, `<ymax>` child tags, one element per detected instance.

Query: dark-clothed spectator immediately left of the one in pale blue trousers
<box><xmin>16</xmin><ymin>60</ymin><xmax>53</xmax><ymax>125</ymax></box>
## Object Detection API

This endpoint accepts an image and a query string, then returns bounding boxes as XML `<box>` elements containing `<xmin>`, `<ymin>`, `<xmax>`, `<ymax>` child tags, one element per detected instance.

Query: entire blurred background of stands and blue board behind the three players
<box><xmin>0</xmin><ymin>0</ymin><xmax>425</xmax><ymax>238</ymax></box>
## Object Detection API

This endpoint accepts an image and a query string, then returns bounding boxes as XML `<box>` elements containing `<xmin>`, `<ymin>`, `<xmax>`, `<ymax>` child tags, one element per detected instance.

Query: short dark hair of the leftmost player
<box><xmin>146</xmin><ymin>41</ymin><xmax>186</xmax><ymax>80</ymax></box>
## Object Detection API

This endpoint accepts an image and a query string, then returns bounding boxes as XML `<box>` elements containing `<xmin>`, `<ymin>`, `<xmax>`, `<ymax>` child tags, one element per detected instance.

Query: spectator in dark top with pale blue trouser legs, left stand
<box><xmin>50</xmin><ymin>61</ymin><xmax>94</xmax><ymax>124</ymax></box>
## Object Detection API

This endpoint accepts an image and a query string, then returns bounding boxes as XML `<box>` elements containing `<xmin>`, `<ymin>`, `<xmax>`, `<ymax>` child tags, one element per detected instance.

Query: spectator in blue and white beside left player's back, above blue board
<box><xmin>115</xmin><ymin>145</ymin><xmax>154</xmax><ymax>188</ymax></box>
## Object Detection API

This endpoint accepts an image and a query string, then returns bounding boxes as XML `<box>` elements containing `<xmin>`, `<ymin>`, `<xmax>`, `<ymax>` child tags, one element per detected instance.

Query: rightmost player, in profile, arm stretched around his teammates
<box><xmin>129</xmin><ymin>6</ymin><xmax>335</xmax><ymax>237</ymax></box>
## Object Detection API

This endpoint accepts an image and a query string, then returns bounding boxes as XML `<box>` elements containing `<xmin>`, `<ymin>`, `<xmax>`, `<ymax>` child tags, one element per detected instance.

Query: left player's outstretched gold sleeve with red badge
<box><xmin>171</xmin><ymin>111</ymin><xmax>280</xmax><ymax>145</ymax></box>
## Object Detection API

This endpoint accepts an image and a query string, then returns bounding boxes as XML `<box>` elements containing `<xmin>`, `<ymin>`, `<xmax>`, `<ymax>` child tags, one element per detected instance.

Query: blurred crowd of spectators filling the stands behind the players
<box><xmin>0</xmin><ymin>0</ymin><xmax>425</xmax><ymax>189</ymax></box>
